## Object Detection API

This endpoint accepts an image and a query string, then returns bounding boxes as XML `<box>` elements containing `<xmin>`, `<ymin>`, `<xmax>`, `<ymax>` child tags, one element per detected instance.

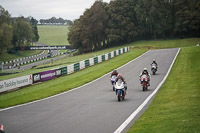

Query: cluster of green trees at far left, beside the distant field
<box><xmin>0</xmin><ymin>5</ymin><xmax>39</xmax><ymax>53</ymax></box>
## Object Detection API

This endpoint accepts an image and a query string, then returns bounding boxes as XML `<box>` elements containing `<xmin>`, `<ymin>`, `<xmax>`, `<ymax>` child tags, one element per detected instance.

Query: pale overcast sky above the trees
<box><xmin>0</xmin><ymin>0</ymin><xmax>110</xmax><ymax>20</ymax></box>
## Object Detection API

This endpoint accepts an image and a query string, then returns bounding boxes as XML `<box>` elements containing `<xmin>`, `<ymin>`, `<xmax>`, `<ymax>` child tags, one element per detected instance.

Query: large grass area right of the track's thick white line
<box><xmin>128</xmin><ymin>47</ymin><xmax>200</xmax><ymax>133</ymax></box>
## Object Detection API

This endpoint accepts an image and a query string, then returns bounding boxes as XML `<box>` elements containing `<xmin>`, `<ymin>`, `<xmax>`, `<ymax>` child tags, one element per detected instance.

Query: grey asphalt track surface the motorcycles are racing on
<box><xmin>0</xmin><ymin>49</ymin><xmax>178</xmax><ymax>133</ymax></box>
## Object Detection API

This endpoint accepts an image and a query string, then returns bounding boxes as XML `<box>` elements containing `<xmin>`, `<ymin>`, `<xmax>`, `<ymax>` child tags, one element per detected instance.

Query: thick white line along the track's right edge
<box><xmin>114</xmin><ymin>48</ymin><xmax>180</xmax><ymax>133</ymax></box>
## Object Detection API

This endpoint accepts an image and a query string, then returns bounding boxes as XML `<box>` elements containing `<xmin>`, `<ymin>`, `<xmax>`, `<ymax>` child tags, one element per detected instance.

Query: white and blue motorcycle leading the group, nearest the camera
<box><xmin>114</xmin><ymin>80</ymin><xmax>126</xmax><ymax>102</ymax></box>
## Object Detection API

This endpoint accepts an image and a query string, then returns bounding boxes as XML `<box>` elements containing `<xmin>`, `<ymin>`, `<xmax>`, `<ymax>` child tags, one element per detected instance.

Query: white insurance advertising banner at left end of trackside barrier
<box><xmin>0</xmin><ymin>75</ymin><xmax>33</xmax><ymax>92</ymax></box>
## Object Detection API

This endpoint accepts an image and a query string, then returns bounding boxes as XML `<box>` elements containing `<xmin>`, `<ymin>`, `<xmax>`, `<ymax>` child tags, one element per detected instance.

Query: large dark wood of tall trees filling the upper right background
<box><xmin>68</xmin><ymin>0</ymin><xmax>200</xmax><ymax>52</ymax></box>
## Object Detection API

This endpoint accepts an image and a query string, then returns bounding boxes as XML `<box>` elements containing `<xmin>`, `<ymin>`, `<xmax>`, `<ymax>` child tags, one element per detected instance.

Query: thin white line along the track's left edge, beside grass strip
<box><xmin>0</xmin><ymin>50</ymin><xmax>150</xmax><ymax>112</ymax></box>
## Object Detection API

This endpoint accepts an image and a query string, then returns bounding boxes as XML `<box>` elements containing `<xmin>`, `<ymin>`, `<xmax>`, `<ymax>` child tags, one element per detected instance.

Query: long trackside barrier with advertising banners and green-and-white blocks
<box><xmin>0</xmin><ymin>47</ymin><xmax>129</xmax><ymax>92</ymax></box>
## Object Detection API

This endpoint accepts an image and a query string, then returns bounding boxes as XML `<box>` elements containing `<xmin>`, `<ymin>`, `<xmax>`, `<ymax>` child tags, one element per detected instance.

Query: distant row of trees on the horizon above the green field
<box><xmin>40</xmin><ymin>17</ymin><xmax>73</xmax><ymax>25</ymax></box>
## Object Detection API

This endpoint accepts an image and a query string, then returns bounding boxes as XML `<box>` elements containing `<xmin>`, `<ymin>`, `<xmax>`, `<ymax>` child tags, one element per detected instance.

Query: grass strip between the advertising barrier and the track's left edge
<box><xmin>0</xmin><ymin>49</ymin><xmax>147</xmax><ymax>108</ymax></box>
